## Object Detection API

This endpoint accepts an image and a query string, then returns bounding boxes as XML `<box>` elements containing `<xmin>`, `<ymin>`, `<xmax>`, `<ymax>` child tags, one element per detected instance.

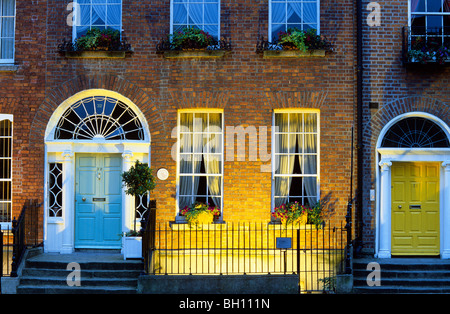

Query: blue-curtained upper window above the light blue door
<box><xmin>73</xmin><ymin>0</ymin><xmax>122</xmax><ymax>39</ymax></box>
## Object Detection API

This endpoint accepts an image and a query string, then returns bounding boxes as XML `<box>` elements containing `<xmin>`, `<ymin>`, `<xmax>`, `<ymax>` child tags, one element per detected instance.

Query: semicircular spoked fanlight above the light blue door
<box><xmin>55</xmin><ymin>96</ymin><xmax>144</xmax><ymax>140</ymax></box>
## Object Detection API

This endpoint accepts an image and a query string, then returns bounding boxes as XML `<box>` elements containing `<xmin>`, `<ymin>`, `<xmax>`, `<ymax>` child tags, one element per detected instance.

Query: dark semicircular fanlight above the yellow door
<box><xmin>381</xmin><ymin>117</ymin><xmax>450</xmax><ymax>148</ymax></box>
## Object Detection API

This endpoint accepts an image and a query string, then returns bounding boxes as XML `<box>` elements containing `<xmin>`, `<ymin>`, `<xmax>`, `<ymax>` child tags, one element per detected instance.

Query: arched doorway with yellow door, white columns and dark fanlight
<box><xmin>376</xmin><ymin>112</ymin><xmax>450</xmax><ymax>258</ymax></box>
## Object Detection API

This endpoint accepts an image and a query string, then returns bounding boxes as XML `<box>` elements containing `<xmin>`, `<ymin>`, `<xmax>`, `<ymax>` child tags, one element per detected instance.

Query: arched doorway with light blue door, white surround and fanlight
<box><xmin>44</xmin><ymin>89</ymin><xmax>150</xmax><ymax>253</ymax></box>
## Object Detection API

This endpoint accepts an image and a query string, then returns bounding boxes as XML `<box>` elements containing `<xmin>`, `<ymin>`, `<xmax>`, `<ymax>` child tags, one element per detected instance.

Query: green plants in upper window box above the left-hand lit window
<box><xmin>169</xmin><ymin>27</ymin><xmax>214</xmax><ymax>49</ymax></box>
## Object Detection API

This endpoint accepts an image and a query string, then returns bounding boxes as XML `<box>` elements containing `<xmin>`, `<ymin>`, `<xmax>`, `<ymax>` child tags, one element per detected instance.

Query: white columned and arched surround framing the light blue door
<box><xmin>44</xmin><ymin>89</ymin><xmax>150</xmax><ymax>254</ymax></box>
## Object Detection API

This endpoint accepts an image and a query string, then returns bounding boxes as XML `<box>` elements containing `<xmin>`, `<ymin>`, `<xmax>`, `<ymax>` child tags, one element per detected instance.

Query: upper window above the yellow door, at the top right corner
<box><xmin>410</xmin><ymin>0</ymin><xmax>450</xmax><ymax>44</ymax></box>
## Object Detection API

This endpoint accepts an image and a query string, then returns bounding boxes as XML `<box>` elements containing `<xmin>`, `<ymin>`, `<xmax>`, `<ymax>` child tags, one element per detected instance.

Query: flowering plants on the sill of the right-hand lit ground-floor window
<box><xmin>272</xmin><ymin>201</ymin><xmax>323</xmax><ymax>228</ymax></box>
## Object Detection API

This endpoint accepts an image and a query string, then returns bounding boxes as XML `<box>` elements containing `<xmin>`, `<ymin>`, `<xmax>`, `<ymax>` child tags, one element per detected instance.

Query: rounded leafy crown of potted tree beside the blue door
<box><xmin>122</xmin><ymin>160</ymin><xmax>156</xmax><ymax>196</ymax></box>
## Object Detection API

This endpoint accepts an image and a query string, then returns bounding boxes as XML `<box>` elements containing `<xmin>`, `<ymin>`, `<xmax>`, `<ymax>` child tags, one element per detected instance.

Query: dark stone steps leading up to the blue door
<box><xmin>17</xmin><ymin>253</ymin><xmax>143</xmax><ymax>294</ymax></box>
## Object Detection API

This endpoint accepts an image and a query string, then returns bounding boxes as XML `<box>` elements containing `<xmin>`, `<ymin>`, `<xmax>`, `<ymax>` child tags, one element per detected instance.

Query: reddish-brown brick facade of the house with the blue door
<box><xmin>0</xmin><ymin>0</ymin><xmax>355</xmax><ymax>231</ymax></box>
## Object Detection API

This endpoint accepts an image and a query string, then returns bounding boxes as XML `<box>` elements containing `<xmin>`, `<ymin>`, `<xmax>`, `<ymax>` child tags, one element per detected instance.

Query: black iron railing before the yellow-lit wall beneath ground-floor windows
<box><xmin>144</xmin><ymin>223</ymin><xmax>346</xmax><ymax>292</ymax></box>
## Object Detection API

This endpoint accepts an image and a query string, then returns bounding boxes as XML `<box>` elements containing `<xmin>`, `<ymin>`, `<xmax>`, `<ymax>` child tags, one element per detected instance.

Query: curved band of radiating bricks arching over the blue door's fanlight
<box><xmin>30</xmin><ymin>74</ymin><xmax>166</xmax><ymax>146</ymax></box>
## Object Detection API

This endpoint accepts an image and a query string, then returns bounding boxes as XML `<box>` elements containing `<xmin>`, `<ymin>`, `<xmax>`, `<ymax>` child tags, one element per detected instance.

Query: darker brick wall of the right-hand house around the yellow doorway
<box><xmin>363</xmin><ymin>1</ymin><xmax>450</xmax><ymax>251</ymax></box>
